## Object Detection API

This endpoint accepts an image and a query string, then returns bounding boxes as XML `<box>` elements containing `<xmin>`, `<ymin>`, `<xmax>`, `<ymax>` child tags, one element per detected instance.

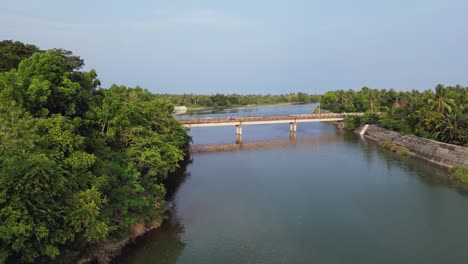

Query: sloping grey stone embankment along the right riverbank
<box><xmin>355</xmin><ymin>125</ymin><xmax>468</xmax><ymax>168</ymax></box>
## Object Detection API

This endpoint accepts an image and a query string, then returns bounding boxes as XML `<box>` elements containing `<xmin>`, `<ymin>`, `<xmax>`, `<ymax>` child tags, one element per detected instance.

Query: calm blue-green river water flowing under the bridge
<box><xmin>116</xmin><ymin>105</ymin><xmax>468</xmax><ymax>264</ymax></box>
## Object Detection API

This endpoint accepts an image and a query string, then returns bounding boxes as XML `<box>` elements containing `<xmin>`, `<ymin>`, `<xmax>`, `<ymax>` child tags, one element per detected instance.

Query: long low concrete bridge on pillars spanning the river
<box><xmin>179</xmin><ymin>113</ymin><xmax>363</xmax><ymax>142</ymax></box>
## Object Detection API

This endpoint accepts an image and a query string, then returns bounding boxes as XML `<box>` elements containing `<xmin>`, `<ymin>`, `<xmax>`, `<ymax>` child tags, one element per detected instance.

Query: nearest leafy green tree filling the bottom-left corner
<box><xmin>0</xmin><ymin>110</ymin><xmax>108</xmax><ymax>262</ymax></box>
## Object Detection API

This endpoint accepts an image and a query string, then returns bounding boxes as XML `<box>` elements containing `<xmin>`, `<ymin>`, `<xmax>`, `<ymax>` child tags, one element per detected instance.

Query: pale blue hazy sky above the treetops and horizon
<box><xmin>0</xmin><ymin>0</ymin><xmax>468</xmax><ymax>94</ymax></box>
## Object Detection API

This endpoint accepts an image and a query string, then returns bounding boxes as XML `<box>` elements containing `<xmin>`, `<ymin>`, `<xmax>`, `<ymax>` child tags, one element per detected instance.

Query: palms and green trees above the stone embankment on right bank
<box><xmin>321</xmin><ymin>84</ymin><xmax>468</xmax><ymax>146</ymax></box>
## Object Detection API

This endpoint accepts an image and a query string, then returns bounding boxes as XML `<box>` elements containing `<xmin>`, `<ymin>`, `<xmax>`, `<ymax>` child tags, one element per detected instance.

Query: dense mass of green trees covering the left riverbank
<box><xmin>0</xmin><ymin>41</ymin><xmax>190</xmax><ymax>263</ymax></box>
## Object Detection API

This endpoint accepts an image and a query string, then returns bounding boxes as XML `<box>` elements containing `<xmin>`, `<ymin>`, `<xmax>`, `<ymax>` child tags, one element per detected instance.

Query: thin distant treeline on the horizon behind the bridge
<box><xmin>155</xmin><ymin>92</ymin><xmax>320</xmax><ymax>108</ymax></box>
